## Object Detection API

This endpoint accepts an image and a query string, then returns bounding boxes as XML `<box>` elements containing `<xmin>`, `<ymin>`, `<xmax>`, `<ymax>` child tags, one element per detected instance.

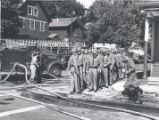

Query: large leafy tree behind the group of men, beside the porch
<box><xmin>87</xmin><ymin>0</ymin><xmax>144</xmax><ymax>47</ymax></box>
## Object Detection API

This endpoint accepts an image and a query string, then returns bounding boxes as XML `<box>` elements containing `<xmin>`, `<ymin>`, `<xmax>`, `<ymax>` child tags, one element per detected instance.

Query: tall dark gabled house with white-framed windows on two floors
<box><xmin>19</xmin><ymin>0</ymin><xmax>51</xmax><ymax>40</ymax></box>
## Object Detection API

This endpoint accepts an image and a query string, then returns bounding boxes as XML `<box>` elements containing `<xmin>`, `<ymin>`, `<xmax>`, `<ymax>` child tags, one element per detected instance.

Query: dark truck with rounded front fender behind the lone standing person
<box><xmin>0</xmin><ymin>46</ymin><xmax>67</xmax><ymax>77</ymax></box>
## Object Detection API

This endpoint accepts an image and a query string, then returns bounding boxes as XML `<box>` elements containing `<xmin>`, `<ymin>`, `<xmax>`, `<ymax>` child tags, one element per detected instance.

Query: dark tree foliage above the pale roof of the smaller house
<box><xmin>42</xmin><ymin>1</ymin><xmax>85</xmax><ymax>18</ymax></box>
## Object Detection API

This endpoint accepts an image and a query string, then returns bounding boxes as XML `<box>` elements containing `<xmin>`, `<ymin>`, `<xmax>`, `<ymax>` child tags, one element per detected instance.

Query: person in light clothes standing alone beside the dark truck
<box><xmin>29</xmin><ymin>51</ymin><xmax>40</xmax><ymax>83</ymax></box>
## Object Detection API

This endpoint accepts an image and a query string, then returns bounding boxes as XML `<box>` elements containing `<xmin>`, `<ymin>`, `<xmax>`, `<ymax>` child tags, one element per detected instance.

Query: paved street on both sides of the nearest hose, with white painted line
<box><xmin>0</xmin><ymin>96</ymin><xmax>152</xmax><ymax>120</ymax></box>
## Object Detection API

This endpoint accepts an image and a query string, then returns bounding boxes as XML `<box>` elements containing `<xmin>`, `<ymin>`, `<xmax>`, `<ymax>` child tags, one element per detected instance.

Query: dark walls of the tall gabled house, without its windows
<box><xmin>19</xmin><ymin>4</ymin><xmax>49</xmax><ymax>39</ymax></box>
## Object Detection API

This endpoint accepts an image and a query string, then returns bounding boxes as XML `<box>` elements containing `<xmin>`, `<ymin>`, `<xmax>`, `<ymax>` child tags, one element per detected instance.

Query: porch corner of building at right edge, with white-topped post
<box><xmin>138</xmin><ymin>0</ymin><xmax>159</xmax><ymax>80</ymax></box>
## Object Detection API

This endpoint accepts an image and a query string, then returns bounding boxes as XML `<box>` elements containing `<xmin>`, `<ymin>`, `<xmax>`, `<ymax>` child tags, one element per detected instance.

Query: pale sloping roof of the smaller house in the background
<box><xmin>49</xmin><ymin>17</ymin><xmax>78</xmax><ymax>27</ymax></box>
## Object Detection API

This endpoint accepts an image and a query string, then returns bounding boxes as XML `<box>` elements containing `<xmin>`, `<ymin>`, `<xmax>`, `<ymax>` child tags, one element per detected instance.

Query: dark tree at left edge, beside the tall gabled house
<box><xmin>1</xmin><ymin>0</ymin><xmax>21</xmax><ymax>38</ymax></box>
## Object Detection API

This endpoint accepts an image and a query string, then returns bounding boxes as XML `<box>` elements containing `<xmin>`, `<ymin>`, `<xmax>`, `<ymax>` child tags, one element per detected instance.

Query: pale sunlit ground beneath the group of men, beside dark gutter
<box><xmin>24</xmin><ymin>77</ymin><xmax>159</xmax><ymax>109</ymax></box>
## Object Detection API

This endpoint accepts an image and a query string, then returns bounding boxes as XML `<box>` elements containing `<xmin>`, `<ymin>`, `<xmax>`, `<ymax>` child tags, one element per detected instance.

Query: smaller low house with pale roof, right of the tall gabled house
<box><xmin>49</xmin><ymin>17</ymin><xmax>85</xmax><ymax>40</ymax></box>
